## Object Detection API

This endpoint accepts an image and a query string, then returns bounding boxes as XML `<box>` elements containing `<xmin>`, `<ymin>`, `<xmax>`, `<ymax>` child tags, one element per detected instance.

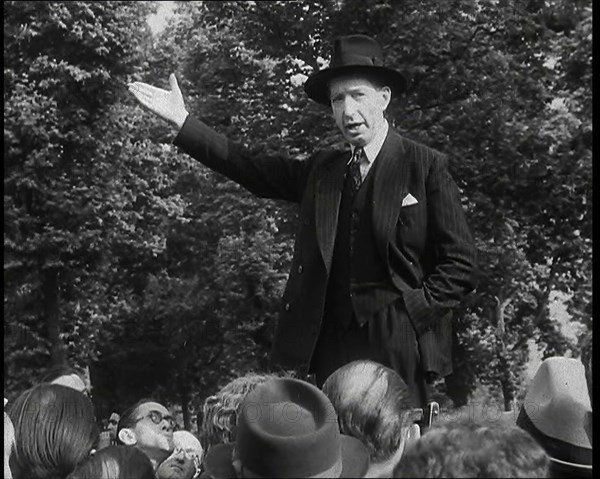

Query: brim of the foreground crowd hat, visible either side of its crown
<box><xmin>204</xmin><ymin>434</ymin><xmax>369</xmax><ymax>479</ymax></box>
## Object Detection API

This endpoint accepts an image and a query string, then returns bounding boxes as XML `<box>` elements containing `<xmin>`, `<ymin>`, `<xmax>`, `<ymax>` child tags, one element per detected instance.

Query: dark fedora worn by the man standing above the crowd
<box><xmin>304</xmin><ymin>35</ymin><xmax>406</xmax><ymax>105</ymax></box>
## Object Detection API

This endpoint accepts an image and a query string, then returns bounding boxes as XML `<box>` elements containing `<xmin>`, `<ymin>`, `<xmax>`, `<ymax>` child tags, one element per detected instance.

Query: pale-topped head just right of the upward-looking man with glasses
<box><xmin>156</xmin><ymin>431</ymin><xmax>203</xmax><ymax>479</ymax></box>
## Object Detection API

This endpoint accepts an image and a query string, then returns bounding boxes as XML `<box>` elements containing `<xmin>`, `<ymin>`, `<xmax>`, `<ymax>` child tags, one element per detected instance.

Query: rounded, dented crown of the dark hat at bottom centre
<box><xmin>236</xmin><ymin>379</ymin><xmax>342</xmax><ymax>477</ymax></box>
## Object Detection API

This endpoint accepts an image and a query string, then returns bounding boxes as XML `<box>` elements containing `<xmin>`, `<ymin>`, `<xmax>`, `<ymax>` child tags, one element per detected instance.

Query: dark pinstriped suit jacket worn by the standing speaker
<box><xmin>174</xmin><ymin>116</ymin><xmax>476</xmax><ymax>375</ymax></box>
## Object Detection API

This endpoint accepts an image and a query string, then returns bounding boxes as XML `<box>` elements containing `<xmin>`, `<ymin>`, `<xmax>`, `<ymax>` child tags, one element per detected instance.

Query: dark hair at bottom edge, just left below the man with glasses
<box><xmin>66</xmin><ymin>446</ymin><xmax>155</xmax><ymax>479</ymax></box>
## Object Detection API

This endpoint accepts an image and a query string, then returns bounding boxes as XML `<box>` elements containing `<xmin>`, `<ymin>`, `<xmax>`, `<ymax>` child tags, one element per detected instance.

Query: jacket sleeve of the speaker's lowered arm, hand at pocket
<box><xmin>403</xmin><ymin>155</ymin><xmax>477</xmax><ymax>334</ymax></box>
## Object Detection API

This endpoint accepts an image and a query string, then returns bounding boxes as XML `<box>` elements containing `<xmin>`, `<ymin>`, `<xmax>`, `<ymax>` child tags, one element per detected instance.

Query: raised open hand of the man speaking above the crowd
<box><xmin>127</xmin><ymin>73</ymin><xmax>188</xmax><ymax>128</ymax></box>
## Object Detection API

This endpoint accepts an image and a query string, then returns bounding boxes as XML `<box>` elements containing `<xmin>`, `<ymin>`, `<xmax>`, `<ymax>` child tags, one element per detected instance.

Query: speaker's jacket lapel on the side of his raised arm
<box><xmin>315</xmin><ymin>152</ymin><xmax>350</xmax><ymax>272</ymax></box>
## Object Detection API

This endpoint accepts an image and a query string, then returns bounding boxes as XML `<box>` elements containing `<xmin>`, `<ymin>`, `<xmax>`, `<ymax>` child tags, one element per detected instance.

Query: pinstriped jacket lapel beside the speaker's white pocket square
<box><xmin>372</xmin><ymin>128</ymin><xmax>410</xmax><ymax>264</ymax></box>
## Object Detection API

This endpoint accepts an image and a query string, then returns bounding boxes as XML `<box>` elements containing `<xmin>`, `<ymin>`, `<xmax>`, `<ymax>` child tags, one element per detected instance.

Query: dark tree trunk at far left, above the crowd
<box><xmin>42</xmin><ymin>268</ymin><xmax>67</xmax><ymax>366</ymax></box>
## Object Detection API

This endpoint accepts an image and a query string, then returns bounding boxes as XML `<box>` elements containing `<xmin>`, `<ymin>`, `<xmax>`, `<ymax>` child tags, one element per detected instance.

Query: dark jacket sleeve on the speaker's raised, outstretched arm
<box><xmin>173</xmin><ymin>115</ymin><xmax>312</xmax><ymax>202</ymax></box>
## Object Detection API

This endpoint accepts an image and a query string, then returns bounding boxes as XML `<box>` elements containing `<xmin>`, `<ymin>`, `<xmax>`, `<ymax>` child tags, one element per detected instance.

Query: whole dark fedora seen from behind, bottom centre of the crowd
<box><xmin>204</xmin><ymin>378</ymin><xmax>369</xmax><ymax>479</ymax></box>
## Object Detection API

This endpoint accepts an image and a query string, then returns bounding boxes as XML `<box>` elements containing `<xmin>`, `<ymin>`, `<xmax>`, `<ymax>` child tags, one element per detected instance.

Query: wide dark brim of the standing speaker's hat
<box><xmin>304</xmin><ymin>65</ymin><xmax>406</xmax><ymax>106</ymax></box>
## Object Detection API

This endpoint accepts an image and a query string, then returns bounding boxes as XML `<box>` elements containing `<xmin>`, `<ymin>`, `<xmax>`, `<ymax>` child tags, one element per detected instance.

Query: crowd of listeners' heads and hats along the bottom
<box><xmin>4</xmin><ymin>341</ymin><xmax>592</xmax><ymax>479</ymax></box>
